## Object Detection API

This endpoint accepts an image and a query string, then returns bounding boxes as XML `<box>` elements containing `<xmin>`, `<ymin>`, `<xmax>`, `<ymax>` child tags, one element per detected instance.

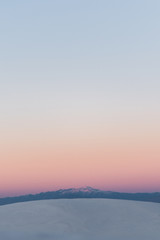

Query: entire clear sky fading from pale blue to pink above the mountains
<box><xmin>0</xmin><ymin>0</ymin><xmax>160</xmax><ymax>196</ymax></box>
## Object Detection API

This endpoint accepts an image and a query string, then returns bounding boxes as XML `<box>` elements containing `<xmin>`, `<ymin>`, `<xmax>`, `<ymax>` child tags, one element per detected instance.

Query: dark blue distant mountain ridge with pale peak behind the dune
<box><xmin>0</xmin><ymin>187</ymin><xmax>160</xmax><ymax>205</ymax></box>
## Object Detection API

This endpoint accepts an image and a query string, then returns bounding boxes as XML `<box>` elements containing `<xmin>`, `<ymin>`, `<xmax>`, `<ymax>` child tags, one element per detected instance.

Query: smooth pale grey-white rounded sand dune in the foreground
<box><xmin>0</xmin><ymin>199</ymin><xmax>160</xmax><ymax>240</ymax></box>
